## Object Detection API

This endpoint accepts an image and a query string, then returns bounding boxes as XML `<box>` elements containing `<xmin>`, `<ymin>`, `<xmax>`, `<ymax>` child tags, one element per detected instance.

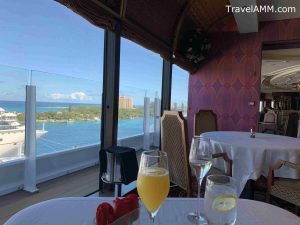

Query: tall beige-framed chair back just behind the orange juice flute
<box><xmin>161</xmin><ymin>111</ymin><xmax>191</xmax><ymax>196</ymax></box>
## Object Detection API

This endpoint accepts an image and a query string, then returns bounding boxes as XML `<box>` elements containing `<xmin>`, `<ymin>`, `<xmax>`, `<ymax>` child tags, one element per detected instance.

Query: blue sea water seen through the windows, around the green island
<box><xmin>0</xmin><ymin>101</ymin><xmax>153</xmax><ymax>155</ymax></box>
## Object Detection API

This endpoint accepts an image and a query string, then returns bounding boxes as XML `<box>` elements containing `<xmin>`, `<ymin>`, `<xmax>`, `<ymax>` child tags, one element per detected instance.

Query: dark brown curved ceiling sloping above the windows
<box><xmin>56</xmin><ymin>0</ymin><xmax>229</xmax><ymax>72</ymax></box>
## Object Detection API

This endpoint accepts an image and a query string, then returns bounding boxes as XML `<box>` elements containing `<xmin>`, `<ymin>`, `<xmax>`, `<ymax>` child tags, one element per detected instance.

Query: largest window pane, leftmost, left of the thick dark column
<box><xmin>0</xmin><ymin>0</ymin><xmax>104</xmax><ymax>193</ymax></box>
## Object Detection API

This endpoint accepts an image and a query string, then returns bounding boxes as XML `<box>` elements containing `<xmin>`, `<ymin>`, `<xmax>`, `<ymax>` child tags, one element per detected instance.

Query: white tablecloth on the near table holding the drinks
<box><xmin>4</xmin><ymin>197</ymin><xmax>300</xmax><ymax>225</ymax></box>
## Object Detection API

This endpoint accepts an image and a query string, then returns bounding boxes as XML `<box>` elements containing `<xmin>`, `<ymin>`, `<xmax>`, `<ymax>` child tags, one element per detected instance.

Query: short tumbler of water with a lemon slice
<box><xmin>204</xmin><ymin>175</ymin><xmax>237</xmax><ymax>225</ymax></box>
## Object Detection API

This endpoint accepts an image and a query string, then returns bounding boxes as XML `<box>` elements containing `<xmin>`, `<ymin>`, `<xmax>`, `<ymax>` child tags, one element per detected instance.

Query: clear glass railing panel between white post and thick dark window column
<box><xmin>32</xmin><ymin>71</ymin><xmax>102</xmax><ymax>155</ymax></box>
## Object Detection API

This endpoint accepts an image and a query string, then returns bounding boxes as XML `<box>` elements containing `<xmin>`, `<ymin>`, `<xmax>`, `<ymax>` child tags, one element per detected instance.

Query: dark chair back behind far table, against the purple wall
<box><xmin>194</xmin><ymin>110</ymin><xmax>218</xmax><ymax>135</ymax></box>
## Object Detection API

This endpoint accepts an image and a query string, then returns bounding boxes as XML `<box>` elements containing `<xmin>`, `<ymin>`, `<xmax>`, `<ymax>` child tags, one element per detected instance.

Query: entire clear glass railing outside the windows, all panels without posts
<box><xmin>0</xmin><ymin>66</ymin><xmax>161</xmax><ymax>162</ymax></box>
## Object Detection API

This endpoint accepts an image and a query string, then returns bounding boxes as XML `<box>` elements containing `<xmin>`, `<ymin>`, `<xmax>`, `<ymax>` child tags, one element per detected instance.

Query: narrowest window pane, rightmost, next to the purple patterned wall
<box><xmin>171</xmin><ymin>65</ymin><xmax>189</xmax><ymax>117</ymax></box>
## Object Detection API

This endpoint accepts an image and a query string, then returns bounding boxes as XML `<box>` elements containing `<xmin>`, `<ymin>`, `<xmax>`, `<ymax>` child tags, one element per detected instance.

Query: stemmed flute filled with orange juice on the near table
<box><xmin>137</xmin><ymin>151</ymin><xmax>170</xmax><ymax>225</ymax></box>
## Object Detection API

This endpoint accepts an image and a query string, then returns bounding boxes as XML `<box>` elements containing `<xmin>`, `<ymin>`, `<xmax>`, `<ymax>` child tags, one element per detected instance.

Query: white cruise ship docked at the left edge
<box><xmin>0</xmin><ymin>107</ymin><xmax>47</xmax><ymax>159</ymax></box>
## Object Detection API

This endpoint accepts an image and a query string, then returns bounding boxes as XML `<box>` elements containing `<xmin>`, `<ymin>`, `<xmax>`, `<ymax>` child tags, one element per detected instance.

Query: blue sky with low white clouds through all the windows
<box><xmin>0</xmin><ymin>0</ymin><xmax>188</xmax><ymax>104</ymax></box>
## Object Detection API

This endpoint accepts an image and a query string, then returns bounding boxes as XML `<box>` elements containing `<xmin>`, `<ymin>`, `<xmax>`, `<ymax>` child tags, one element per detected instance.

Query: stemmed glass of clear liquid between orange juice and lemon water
<box><xmin>188</xmin><ymin>136</ymin><xmax>212</xmax><ymax>224</ymax></box>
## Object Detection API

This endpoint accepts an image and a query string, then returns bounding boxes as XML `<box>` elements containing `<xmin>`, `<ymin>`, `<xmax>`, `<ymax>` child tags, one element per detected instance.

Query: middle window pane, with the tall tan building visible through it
<box><xmin>118</xmin><ymin>38</ymin><xmax>162</xmax><ymax>149</ymax></box>
